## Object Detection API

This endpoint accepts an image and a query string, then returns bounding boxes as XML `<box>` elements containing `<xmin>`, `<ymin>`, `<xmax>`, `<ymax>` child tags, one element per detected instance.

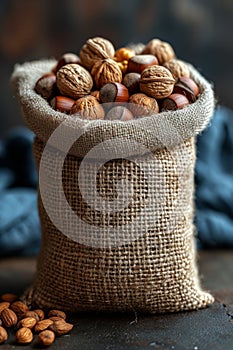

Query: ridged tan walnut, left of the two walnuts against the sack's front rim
<box><xmin>70</xmin><ymin>95</ymin><xmax>105</xmax><ymax>120</ymax></box>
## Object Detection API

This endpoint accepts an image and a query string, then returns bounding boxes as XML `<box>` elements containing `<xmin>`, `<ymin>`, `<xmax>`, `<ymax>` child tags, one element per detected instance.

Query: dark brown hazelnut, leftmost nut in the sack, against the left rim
<box><xmin>35</xmin><ymin>73</ymin><xmax>57</xmax><ymax>100</ymax></box>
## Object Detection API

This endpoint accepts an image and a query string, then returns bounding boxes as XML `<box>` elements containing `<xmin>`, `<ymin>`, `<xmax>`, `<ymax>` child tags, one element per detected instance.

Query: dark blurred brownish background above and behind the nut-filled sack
<box><xmin>0</xmin><ymin>0</ymin><xmax>233</xmax><ymax>137</ymax></box>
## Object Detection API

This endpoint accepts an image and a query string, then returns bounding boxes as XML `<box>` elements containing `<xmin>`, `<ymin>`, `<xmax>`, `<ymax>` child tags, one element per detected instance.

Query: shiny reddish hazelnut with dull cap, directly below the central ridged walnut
<box><xmin>100</xmin><ymin>82</ymin><xmax>129</xmax><ymax>103</ymax></box>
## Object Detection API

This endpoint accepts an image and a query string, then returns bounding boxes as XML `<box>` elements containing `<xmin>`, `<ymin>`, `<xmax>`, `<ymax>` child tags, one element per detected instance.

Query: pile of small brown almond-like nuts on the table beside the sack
<box><xmin>0</xmin><ymin>293</ymin><xmax>73</xmax><ymax>346</ymax></box>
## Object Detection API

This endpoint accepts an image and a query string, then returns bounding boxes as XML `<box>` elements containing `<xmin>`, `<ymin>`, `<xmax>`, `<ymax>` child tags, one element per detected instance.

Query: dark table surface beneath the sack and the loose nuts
<box><xmin>0</xmin><ymin>250</ymin><xmax>233</xmax><ymax>350</ymax></box>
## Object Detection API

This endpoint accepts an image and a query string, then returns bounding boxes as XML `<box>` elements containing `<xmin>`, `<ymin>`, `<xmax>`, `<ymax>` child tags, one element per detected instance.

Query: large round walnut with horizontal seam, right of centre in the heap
<box><xmin>140</xmin><ymin>66</ymin><xmax>175</xmax><ymax>99</ymax></box>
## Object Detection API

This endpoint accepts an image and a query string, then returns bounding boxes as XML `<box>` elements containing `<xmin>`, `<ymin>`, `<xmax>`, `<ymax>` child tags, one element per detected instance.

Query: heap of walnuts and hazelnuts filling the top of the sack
<box><xmin>35</xmin><ymin>37</ymin><xmax>199</xmax><ymax>121</ymax></box>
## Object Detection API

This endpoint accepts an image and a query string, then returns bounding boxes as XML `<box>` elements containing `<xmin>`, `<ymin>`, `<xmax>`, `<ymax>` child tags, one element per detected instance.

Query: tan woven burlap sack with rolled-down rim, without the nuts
<box><xmin>12</xmin><ymin>60</ymin><xmax>214</xmax><ymax>313</ymax></box>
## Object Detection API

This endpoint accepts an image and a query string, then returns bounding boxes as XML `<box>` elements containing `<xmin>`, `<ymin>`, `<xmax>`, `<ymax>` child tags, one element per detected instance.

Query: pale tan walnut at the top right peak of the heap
<box><xmin>142</xmin><ymin>39</ymin><xmax>175</xmax><ymax>64</ymax></box>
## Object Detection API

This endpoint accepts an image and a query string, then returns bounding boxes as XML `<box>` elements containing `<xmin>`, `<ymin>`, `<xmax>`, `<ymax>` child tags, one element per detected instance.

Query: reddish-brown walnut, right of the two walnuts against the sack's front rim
<box><xmin>129</xmin><ymin>93</ymin><xmax>159</xmax><ymax>118</ymax></box>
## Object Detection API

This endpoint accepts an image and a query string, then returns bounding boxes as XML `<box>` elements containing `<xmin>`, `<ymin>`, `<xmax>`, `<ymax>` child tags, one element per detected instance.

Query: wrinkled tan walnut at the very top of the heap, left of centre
<box><xmin>79</xmin><ymin>37</ymin><xmax>115</xmax><ymax>69</ymax></box>
